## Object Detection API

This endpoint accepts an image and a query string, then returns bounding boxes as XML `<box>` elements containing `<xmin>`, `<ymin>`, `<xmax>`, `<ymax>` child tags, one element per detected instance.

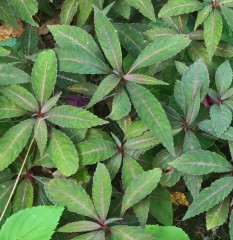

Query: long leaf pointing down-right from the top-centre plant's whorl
<box><xmin>127</xmin><ymin>83</ymin><xmax>174</xmax><ymax>154</ymax></box>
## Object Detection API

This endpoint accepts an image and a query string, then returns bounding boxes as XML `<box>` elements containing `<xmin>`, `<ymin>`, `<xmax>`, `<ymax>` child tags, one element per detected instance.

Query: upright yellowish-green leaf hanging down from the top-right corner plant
<box><xmin>204</xmin><ymin>10</ymin><xmax>223</xmax><ymax>60</ymax></box>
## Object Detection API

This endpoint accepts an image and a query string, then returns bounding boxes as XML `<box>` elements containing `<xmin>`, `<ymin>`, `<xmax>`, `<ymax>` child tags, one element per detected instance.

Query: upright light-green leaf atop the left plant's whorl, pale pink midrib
<box><xmin>32</xmin><ymin>50</ymin><xmax>57</xmax><ymax>107</ymax></box>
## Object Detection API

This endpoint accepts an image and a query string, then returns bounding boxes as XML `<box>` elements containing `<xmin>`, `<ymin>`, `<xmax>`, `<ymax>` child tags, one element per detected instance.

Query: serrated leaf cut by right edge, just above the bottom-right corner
<box><xmin>183</xmin><ymin>177</ymin><xmax>233</xmax><ymax>220</ymax></box>
